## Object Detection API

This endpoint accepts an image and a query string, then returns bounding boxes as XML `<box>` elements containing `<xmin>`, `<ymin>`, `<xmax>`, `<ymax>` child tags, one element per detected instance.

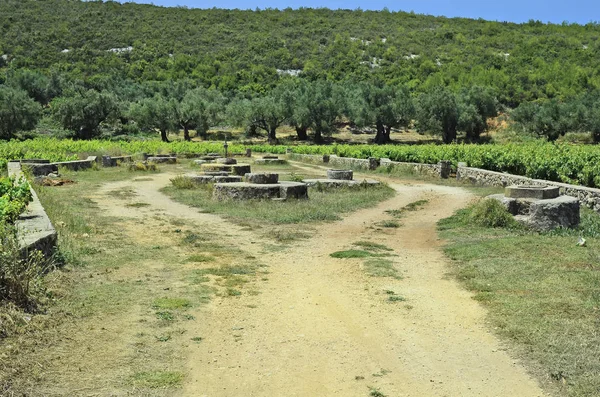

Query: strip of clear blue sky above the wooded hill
<box><xmin>120</xmin><ymin>0</ymin><xmax>600</xmax><ymax>24</ymax></box>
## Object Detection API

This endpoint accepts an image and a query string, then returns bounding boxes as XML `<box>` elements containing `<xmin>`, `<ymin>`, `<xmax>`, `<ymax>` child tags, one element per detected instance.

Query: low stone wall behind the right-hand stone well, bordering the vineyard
<box><xmin>456</xmin><ymin>166</ymin><xmax>600</xmax><ymax>212</ymax></box>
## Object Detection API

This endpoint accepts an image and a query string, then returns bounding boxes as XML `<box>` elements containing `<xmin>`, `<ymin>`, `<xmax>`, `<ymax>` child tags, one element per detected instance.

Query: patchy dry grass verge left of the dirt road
<box><xmin>0</xmin><ymin>168</ymin><xmax>265</xmax><ymax>396</ymax></box>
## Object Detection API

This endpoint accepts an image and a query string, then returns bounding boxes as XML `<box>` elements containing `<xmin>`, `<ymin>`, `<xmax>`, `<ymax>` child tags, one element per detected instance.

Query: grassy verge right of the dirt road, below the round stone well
<box><xmin>439</xmin><ymin>207</ymin><xmax>600</xmax><ymax>397</ymax></box>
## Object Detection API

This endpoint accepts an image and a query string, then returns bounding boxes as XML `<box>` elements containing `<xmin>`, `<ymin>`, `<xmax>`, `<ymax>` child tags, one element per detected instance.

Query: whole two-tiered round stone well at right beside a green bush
<box><xmin>488</xmin><ymin>185</ymin><xmax>580</xmax><ymax>231</ymax></box>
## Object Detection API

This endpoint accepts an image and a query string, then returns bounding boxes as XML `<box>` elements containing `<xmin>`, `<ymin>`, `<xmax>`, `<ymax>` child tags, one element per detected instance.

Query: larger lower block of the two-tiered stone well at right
<box><xmin>515</xmin><ymin>196</ymin><xmax>580</xmax><ymax>231</ymax></box>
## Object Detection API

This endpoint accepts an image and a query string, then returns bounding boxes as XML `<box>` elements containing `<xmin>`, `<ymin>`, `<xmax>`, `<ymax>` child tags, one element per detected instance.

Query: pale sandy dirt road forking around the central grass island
<box><xmin>96</xmin><ymin>167</ymin><xmax>545</xmax><ymax>397</ymax></box>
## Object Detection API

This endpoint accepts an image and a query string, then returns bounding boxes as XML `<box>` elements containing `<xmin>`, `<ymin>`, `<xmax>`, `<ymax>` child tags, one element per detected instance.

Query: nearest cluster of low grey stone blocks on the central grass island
<box><xmin>213</xmin><ymin>172</ymin><xmax>308</xmax><ymax>200</ymax></box>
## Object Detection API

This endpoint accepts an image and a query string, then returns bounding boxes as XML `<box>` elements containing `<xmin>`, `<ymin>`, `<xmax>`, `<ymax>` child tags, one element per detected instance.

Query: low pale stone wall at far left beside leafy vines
<box><xmin>8</xmin><ymin>161</ymin><xmax>57</xmax><ymax>257</ymax></box>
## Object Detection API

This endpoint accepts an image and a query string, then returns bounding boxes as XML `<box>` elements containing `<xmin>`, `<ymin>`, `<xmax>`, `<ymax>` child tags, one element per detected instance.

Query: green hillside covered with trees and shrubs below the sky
<box><xmin>0</xmin><ymin>0</ymin><xmax>600</xmax><ymax>143</ymax></box>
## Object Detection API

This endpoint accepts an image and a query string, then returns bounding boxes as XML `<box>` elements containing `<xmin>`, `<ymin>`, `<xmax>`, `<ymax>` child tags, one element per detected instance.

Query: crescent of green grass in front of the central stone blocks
<box><xmin>162</xmin><ymin>185</ymin><xmax>395</xmax><ymax>224</ymax></box>
